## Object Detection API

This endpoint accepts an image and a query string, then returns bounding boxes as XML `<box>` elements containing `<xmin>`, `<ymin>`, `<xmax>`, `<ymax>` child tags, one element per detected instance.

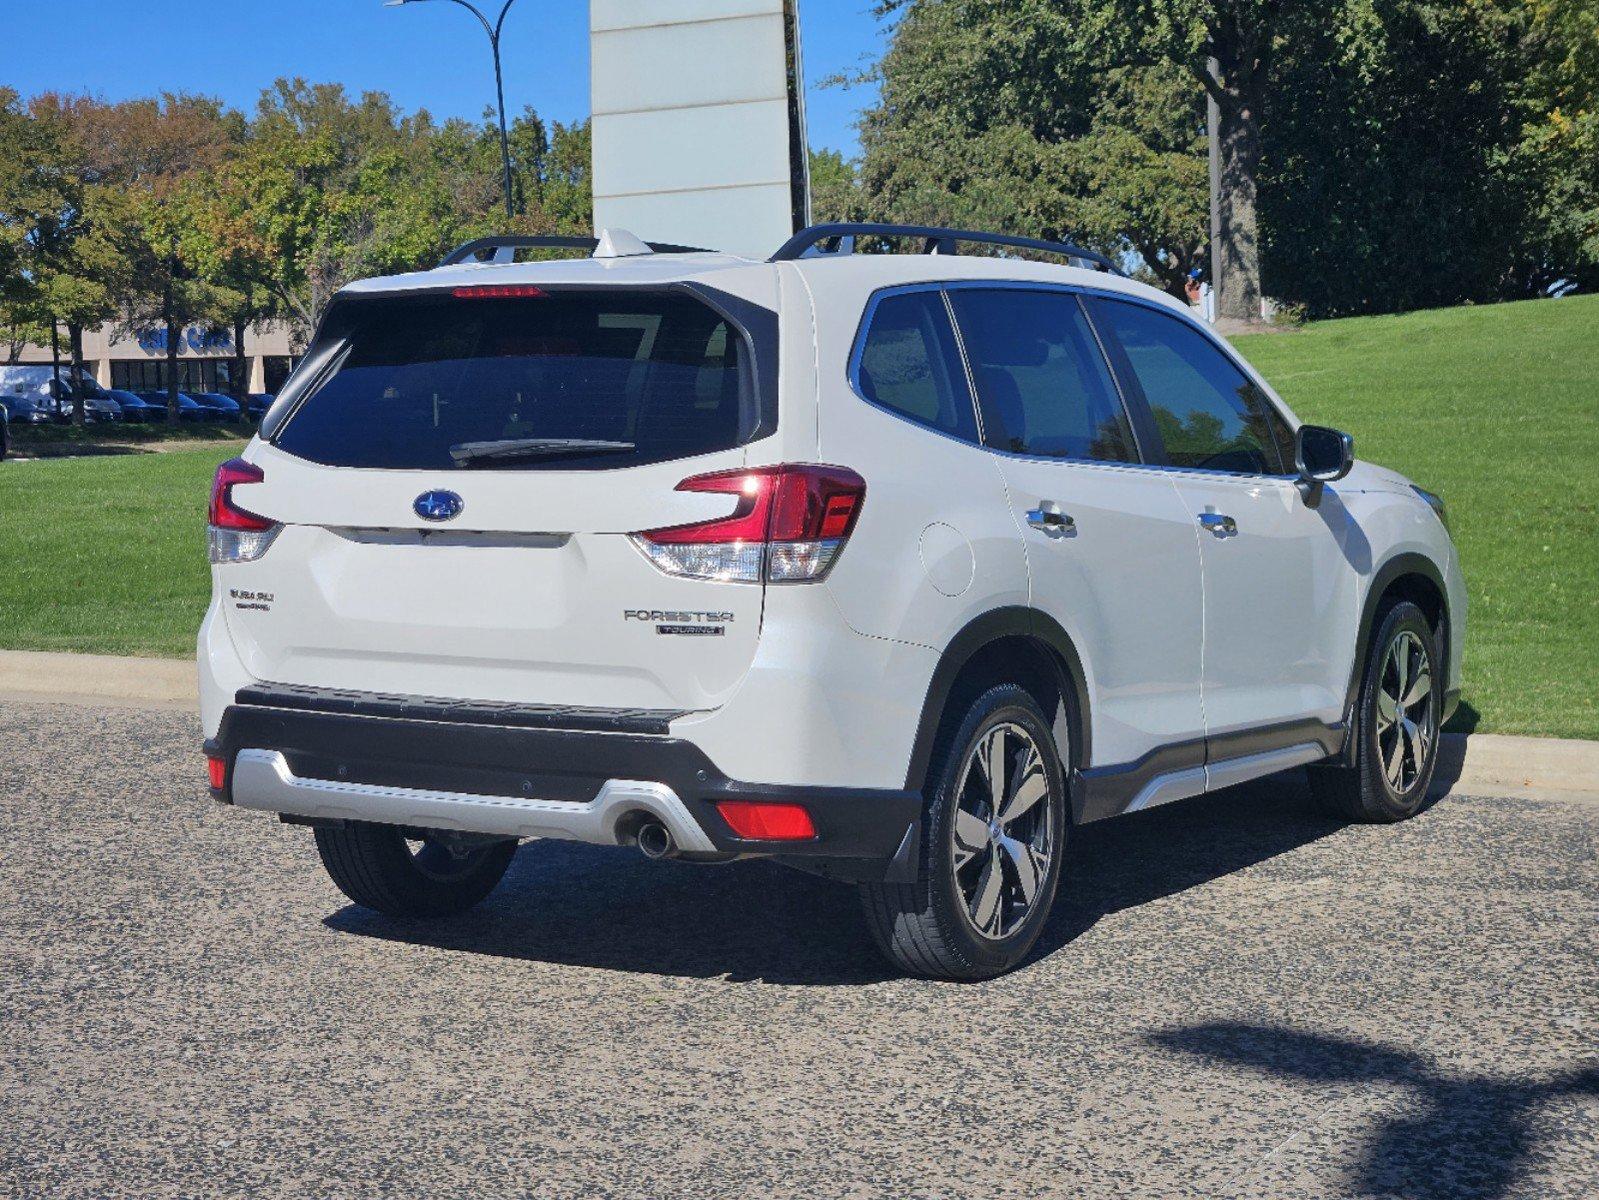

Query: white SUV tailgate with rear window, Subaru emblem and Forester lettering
<box><xmin>217</xmin><ymin>288</ymin><xmax>774</xmax><ymax>710</ymax></box>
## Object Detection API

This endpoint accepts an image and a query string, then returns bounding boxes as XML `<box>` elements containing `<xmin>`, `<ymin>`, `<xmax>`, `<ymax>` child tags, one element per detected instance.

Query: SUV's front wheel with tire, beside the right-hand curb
<box><xmin>1310</xmin><ymin>600</ymin><xmax>1444</xmax><ymax>824</ymax></box>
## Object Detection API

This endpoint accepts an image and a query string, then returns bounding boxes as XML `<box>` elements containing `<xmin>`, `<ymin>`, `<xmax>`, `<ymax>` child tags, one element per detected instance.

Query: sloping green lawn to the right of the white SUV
<box><xmin>1236</xmin><ymin>296</ymin><xmax>1599</xmax><ymax>738</ymax></box>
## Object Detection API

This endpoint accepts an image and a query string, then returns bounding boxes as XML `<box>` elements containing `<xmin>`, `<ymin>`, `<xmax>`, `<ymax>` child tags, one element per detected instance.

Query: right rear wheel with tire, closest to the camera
<box><xmin>860</xmin><ymin>683</ymin><xmax>1067</xmax><ymax>979</ymax></box>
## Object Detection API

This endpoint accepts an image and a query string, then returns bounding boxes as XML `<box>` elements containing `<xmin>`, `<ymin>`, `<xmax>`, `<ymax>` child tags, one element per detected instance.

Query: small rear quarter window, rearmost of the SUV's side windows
<box><xmin>855</xmin><ymin>291</ymin><xmax>977</xmax><ymax>442</ymax></box>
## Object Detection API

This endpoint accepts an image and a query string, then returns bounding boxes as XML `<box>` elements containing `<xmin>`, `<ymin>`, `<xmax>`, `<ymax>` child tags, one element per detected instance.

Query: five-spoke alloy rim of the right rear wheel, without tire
<box><xmin>950</xmin><ymin>723</ymin><xmax>1057</xmax><ymax>941</ymax></box>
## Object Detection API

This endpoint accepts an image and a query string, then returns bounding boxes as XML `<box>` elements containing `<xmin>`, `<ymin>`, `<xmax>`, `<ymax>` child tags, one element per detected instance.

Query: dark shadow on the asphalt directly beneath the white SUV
<box><xmin>325</xmin><ymin>774</ymin><xmax>1340</xmax><ymax>986</ymax></box>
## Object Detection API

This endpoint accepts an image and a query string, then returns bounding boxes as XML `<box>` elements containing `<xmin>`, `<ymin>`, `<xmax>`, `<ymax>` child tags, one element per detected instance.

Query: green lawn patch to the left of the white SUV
<box><xmin>0</xmin><ymin>440</ymin><xmax>243</xmax><ymax>658</ymax></box>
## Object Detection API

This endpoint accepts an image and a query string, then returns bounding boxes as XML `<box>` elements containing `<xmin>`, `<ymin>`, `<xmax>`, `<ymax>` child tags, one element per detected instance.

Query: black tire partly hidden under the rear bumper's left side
<box><xmin>317</xmin><ymin>821</ymin><xmax>516</xmax><ymax>917</ymax></box>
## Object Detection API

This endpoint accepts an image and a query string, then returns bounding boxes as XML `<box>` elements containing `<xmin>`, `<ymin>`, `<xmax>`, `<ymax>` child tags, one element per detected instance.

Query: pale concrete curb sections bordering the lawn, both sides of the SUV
<box><xmin>0</xmin><ymin>650</ymin><xmax>1599</xmax><ymax>803</ymax></box>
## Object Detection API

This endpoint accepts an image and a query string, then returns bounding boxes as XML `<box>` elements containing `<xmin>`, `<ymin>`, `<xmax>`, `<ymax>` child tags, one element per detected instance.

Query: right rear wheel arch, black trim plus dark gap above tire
<box><xmin>905</xmin><ymin>605</ymin><xmax>1092</xmax><ymax>790</ymax></box>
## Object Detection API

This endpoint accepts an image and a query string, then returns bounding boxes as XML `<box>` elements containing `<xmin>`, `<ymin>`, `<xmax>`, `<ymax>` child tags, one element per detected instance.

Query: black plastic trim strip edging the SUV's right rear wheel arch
<box><xmin>905</xmin><ymin>605</ymin><xmax>1092</xmax><ymax>792</ymax></box>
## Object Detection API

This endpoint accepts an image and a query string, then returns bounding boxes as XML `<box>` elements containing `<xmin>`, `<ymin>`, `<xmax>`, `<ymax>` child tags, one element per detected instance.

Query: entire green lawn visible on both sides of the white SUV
<box><xmin>0</xmin><ymin>296</ymin><xmax>1599</xmax><ymax>738</ymax></box>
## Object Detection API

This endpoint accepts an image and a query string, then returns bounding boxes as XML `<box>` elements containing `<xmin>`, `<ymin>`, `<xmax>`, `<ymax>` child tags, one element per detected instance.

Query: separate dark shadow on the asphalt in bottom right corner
<box><xmin>1150</xmin><ymin>1024</ymin><xmax>1599</xmax><ymax>1200</ymax></box>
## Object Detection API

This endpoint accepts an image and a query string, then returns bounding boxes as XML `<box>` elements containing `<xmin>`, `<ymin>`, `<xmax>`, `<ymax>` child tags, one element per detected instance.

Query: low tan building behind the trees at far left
<box><xmin>18</xmin><ymin>325</ymin><xmax>294</xmax><ymax>394</ymax></box>
